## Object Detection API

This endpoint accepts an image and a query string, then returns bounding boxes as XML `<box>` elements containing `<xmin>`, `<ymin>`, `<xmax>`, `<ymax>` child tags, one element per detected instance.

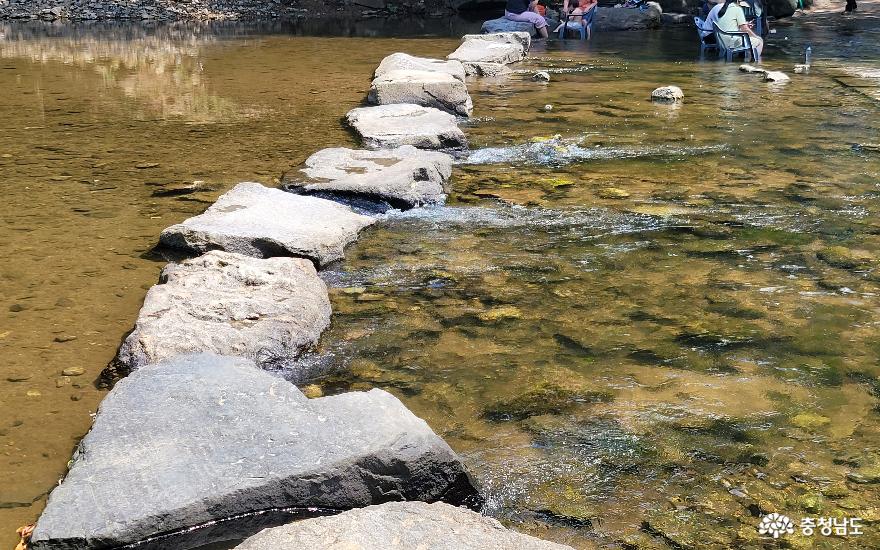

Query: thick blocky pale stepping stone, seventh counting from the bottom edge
<box><xmin>367</xmin><ymin>69</ymin><xmax>474</xmax><ymax>116</ymax></box>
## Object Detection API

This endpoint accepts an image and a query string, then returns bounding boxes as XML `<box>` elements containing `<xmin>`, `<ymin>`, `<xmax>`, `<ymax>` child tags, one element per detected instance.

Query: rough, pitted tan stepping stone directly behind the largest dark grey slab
<box><xmin>111</xmin><ymin>251</ymin><xmax>330</xmax><ymax>382</ymax></box>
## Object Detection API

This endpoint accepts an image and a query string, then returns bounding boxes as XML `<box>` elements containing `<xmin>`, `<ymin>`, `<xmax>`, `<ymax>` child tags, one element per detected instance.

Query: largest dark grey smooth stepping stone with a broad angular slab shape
<box><xmin>31</xmin><ymin>354</ymin><xmax>479</xmax><ymax>550</ymax></box>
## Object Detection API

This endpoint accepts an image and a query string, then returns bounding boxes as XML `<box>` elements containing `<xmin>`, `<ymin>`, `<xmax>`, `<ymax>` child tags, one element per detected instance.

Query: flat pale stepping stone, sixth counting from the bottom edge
<box><xmin>346</xmin><ymin>103</ymin><xmax>467</xmax><ymax>149</ymax></box>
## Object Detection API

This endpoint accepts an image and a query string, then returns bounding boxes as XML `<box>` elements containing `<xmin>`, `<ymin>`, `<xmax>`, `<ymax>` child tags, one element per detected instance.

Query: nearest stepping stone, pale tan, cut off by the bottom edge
<box><xmin>235</xmin><ymin>502</ymin><xmax>571</xmax><ymax>550</ymax></box>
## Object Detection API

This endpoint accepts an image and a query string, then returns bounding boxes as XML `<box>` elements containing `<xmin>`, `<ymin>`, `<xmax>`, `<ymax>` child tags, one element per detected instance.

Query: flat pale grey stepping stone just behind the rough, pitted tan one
<box><xmin>159</xmin><ymin>182</ymin><xmax>375</xmax><ymax>266</ymax></box>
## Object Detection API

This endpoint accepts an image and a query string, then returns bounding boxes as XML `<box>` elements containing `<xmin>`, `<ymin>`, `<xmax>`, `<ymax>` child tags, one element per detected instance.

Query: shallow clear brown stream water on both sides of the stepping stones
<box><xmin>0</xmin><ymin>11</ymin><xmax>880</xmax><ymax>548</ymax></box>
